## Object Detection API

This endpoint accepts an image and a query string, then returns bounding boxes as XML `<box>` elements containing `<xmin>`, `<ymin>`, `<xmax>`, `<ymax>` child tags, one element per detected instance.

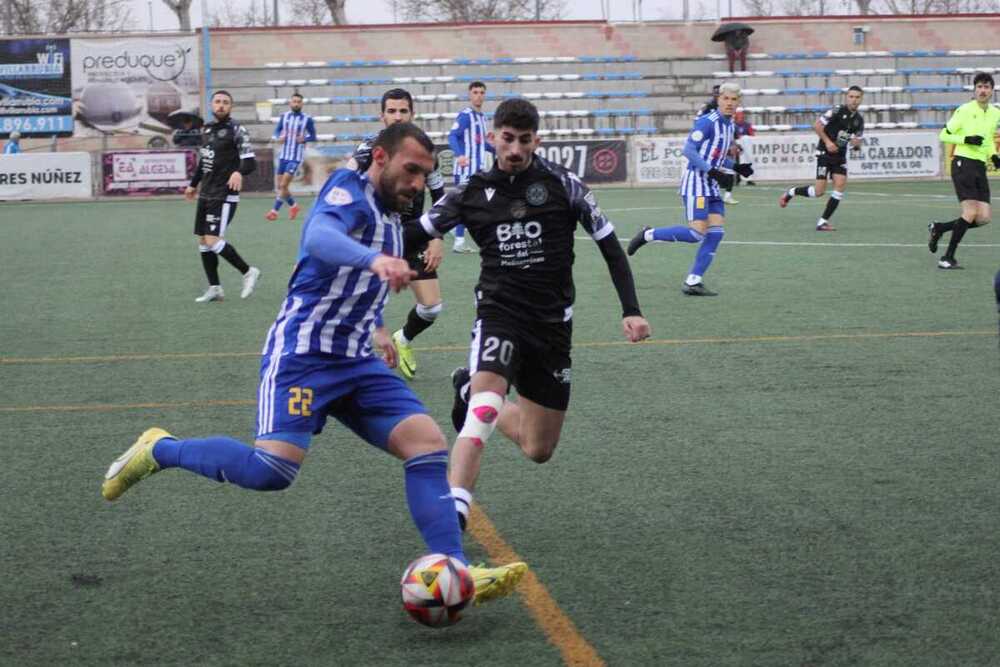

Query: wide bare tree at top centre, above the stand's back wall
<box><xmin>399</xmin><ymin>0</ymin><xmax>566</xmax><ymax>23</ymax></box>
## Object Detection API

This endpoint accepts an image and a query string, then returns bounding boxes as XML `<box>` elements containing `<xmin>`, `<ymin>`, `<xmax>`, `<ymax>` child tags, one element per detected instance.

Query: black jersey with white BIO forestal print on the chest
<box><xmin>420</xmin><ymin>155</ymin><xmax>614</xmax><ymax>322</ymax></box>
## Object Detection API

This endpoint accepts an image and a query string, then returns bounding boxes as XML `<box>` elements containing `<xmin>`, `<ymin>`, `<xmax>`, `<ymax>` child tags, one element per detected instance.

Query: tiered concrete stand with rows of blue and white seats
<box><xmin>216</xmin><ymin>44</ymin><xmax>1000</xmax><ymax>141</ymax></box>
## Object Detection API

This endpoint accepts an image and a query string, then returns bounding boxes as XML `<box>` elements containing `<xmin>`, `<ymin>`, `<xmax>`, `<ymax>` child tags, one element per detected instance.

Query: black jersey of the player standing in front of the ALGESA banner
<box><xmin>191</xmin><ymin>118</ymin><xmax>256</xmax><ymax>201</ymax></box>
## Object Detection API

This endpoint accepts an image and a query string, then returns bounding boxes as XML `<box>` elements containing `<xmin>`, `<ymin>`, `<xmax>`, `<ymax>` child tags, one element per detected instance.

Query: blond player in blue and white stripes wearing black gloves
<box><xmin>628</xmin><ymin>83</ymin><xmax>753</xmax><ymax>296</ymax></box>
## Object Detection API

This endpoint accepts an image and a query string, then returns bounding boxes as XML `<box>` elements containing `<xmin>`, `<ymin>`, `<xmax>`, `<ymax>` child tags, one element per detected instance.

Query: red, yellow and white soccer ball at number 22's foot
<box><xmin>399</xmin><ymin>554</ymin><xmax>476</xmax><ymax>628</ymax></box>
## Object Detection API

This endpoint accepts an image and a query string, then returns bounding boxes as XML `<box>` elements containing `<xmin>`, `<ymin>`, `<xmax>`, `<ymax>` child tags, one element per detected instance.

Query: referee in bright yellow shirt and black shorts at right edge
<box><xmin>927</xmin><ymin>72</ymin><xmax>1000</xmax><ymax>269</ymax></box>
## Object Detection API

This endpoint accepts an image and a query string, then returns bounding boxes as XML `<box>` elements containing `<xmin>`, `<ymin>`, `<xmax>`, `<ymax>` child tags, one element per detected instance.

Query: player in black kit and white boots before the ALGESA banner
<box><xmin>184</xmin><ymin>90</ymin><xmax>260</xmax><ymax>303</ymax></box>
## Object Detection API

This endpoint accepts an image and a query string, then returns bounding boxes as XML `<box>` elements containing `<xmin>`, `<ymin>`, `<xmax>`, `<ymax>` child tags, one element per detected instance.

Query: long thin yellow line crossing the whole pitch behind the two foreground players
<box><xmin>0</xmin><ymin>330</ymin><xmax>997</xmax><ymax>366</ymax></box>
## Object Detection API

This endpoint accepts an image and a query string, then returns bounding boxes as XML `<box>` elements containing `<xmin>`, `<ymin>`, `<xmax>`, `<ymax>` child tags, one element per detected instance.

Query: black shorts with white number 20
<box><xmin>469</xmin><ymin>309</ymin><xmax>573</xmax><ymax>411</ymax></box>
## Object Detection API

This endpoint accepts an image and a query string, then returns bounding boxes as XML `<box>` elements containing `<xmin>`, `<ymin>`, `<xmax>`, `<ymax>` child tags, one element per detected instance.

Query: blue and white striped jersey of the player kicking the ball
<box><xmin>263</xmin><ymin>169</ymin><xmax>403</xmax><ymax>362</ymax></box>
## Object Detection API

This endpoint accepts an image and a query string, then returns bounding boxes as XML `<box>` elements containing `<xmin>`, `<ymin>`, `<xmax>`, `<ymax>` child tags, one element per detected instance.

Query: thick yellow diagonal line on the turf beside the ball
<box><xmin>469</xmin><ymin>505</ymin><xmax>605</xmax><ymax>667</ymax></box>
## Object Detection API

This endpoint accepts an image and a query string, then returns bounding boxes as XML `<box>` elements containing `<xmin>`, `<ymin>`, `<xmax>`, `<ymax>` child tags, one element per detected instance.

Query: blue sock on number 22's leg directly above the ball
<box><xmin>403</xmin><ymin>449</ymin><xmax>469</xmax><ymax>564</ymax></box>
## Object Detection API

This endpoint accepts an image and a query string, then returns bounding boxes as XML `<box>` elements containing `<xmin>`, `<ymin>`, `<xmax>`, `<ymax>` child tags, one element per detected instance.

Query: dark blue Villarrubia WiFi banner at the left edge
<box><xmin>0</xmin><ymin>39</ymin><xmax>73</xmax><ymax>138</ymax></box>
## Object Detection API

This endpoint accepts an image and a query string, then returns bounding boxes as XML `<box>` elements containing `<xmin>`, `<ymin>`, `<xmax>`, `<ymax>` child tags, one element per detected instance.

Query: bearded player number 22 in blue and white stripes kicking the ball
<box><xmin>101</xmin><ymin>123</ymin><xmax>527</xmax><ymax>602</ymax></box>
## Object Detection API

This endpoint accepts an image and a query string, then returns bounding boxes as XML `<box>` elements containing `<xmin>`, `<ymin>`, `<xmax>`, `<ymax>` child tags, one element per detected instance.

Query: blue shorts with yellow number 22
<box><xmin>257</xmin><ymin>355</ymin><xmax>427</xmax><ymax>449</ymax></box>
